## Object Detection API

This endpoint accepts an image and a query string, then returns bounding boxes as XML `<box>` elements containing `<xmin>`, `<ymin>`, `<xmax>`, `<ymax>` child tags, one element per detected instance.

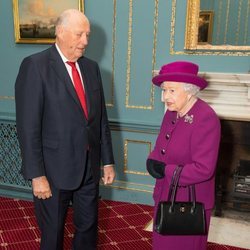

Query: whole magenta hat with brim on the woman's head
<box><xmin>152</xmin><ymin>61</ymin><xmax>207</xmax><ymax>89</ymax></box>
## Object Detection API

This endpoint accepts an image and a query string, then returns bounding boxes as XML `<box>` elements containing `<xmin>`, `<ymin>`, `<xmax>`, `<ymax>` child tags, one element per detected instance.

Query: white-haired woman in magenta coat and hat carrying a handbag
<box><xmin>147</xmin><ymin>61</ymin><xmax>220</xmax><ymax>250</ymax></box>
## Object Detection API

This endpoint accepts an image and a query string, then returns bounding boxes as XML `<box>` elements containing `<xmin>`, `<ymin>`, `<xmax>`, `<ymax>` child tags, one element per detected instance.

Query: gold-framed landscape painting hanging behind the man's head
<box><xmin>13</xmin><ymin>0</ymin><xmax>84</xmax><ymax>44</ymax></box>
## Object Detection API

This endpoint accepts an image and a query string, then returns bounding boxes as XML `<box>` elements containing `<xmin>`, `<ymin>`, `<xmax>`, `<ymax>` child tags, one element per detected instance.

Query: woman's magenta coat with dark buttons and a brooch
<box><xmin>148</xmin><ymin>99</ymin><xmax>220</xmax><ymax>250</ymax></box>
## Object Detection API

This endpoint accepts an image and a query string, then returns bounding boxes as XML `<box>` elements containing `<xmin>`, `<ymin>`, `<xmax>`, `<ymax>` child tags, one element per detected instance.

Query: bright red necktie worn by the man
<box><xmin>67</xmin><ymin>62</ymin><xmax>88</xmax><ymax>119</ymax></box>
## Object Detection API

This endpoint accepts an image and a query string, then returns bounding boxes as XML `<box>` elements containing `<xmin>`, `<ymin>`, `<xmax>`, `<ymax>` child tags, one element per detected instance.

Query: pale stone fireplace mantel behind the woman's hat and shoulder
<box><xmin>154</xmin><ymin>71</ymin><xmax>250</xmax><ymax>121</ymax></box>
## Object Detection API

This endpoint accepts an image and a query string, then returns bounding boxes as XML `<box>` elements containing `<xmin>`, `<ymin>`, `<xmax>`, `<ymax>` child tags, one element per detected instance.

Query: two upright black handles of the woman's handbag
<box><xmin>168</xmin><ymin>165</ymin><xmax>196</xmax><ymax>213</ymax></box>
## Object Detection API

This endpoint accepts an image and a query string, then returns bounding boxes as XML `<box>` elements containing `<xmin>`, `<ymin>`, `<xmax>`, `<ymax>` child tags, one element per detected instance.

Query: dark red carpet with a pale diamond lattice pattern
<box><xmin>0</xmin><ymin>197</ymin><xmax>248</xmax><ymax>250</ymax></box>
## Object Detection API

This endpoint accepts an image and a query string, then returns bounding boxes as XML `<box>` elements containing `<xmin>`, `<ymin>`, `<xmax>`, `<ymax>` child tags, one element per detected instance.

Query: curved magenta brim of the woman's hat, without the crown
<box><xmin>152</xmin><ymin>73</ymin><xmax>208</xmax><ymax>89</ymax></box>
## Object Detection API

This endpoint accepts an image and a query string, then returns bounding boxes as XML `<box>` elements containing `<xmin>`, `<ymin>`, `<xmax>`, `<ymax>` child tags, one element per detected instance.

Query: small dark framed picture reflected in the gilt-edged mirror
<box><xmin>198</xmin><ymin>11</ymin><xmax>214</xmax><ymax>44</ymax></box>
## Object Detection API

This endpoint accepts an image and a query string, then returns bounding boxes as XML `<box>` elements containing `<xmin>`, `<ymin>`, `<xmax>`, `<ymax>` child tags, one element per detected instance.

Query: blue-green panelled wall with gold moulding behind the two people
<box><xmin>0</xmin><ymin>0</ymin><xmax>250</xmax><ymax>204</ymax></box>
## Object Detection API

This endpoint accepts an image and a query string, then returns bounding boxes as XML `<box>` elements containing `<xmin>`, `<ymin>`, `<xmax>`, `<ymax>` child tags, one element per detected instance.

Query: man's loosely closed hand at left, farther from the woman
<box><xmin>32</xmin><ymin>176</ymin><xmax>52</xmax><ymax>200</ymax></box>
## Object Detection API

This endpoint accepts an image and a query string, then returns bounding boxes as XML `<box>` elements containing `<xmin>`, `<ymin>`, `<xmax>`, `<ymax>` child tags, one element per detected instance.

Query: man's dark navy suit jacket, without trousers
<box><xmin>15</xmin><ymin>45</ymin><xmax>114</xmax><ymax>190</ymax></box>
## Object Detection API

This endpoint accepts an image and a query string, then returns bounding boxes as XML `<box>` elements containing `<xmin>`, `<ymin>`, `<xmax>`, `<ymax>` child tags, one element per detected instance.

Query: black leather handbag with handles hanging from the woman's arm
<box><xmin>154</xmin><ymin>166</ymin><xmax>207</xmax><ymax>235</ymax></box>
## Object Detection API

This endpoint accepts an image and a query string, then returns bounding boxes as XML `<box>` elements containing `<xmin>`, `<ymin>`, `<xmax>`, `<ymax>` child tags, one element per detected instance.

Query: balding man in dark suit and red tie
<box><xmin>15</xmin><ymin>9</ymin><xmax>115</xmax><ymax>250</ymax></box>
